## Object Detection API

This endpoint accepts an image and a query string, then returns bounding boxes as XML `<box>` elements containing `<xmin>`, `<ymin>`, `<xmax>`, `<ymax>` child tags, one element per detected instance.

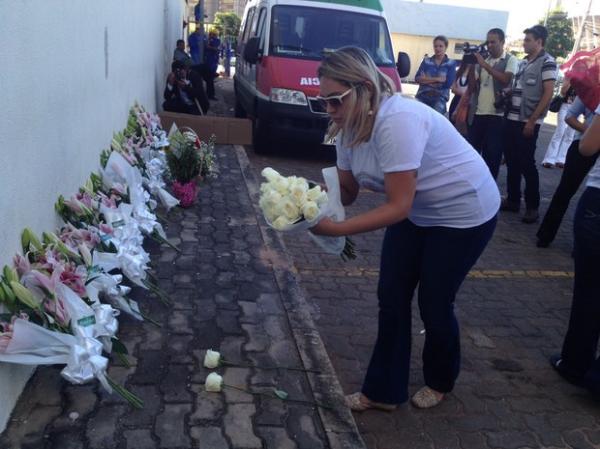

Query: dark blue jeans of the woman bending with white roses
<box><xmin>362</xmin><ymin>217</ymin><xmax>496</xmax><ymax>404</ymax></box>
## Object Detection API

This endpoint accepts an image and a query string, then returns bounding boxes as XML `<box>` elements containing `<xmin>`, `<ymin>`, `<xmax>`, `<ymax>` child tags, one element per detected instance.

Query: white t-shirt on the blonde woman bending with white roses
<box><xmin>336</xmin><ymin>94</ymin><xmax>500</xmax><ymax>228</ymax></box>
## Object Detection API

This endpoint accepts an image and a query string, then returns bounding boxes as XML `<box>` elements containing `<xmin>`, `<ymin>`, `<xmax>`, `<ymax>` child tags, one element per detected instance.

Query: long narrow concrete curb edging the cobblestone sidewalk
<box><xmin>234</xmin><ymin>145</ymin><xmax>366</xmax><ymax>449</ymax></box>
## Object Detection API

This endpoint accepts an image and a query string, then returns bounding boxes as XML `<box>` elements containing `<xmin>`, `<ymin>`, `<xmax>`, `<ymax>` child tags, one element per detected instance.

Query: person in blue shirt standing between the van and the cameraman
<box><xmin>415</xmin><ymin>36</ymin><xmax>456</xmax><ymax>114</ymax></box>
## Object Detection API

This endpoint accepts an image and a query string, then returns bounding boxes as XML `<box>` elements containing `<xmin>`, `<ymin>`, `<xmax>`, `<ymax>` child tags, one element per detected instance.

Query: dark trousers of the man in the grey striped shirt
<box><xmin>504</xmin><ymin>120</ymin><xmax>540</xmax><ymax>209</ymax></box>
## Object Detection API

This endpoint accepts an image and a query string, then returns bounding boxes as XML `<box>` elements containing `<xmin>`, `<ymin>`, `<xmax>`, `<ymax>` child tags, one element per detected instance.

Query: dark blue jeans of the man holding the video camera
<box><xmin>469</xmin><ymin>115</ymin><xmax>504</xmax><ymax>179</ymax></box>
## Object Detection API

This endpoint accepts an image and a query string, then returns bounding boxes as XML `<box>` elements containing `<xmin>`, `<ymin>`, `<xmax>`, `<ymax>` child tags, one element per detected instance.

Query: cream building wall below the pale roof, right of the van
<box><xmin>392</xmin><ymin>33</ymin><xmax>482</xmax><ymax>81</ymax></box>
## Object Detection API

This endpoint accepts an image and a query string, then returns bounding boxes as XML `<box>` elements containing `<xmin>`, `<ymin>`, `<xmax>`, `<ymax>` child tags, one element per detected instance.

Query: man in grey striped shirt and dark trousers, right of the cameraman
<box><xmin>500</xmin><ymin>25</ymin><xmax>557</xmax><ymax>223</ymax></box>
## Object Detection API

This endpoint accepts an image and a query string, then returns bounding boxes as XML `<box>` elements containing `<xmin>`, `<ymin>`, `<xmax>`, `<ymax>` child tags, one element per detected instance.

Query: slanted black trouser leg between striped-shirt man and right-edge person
<box><xmin>537</xmin><ymin>140</ymin><xmax>598</xmax><ymax>243</ymax></box>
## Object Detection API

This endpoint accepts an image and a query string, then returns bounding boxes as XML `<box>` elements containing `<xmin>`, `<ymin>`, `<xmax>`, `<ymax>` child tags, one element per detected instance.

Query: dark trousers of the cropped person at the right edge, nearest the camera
<box><xmin>561</xmin><ymin>187</ymin><xmax>600</xmax><ymax>394</ymax></box>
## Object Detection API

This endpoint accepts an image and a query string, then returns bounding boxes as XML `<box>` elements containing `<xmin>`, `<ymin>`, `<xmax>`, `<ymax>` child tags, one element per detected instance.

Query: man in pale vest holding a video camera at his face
<box><xmin>465</xmin><ymin>28</ymin><xmax>519</xmax><ymax>179</ymax></box>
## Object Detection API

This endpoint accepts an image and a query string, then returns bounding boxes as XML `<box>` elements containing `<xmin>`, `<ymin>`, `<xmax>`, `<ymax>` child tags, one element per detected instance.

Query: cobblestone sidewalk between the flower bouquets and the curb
<box><xmin>0</xmin><ymin>128</ymin><xmax>364</xmax><ymax>449</ymax></box>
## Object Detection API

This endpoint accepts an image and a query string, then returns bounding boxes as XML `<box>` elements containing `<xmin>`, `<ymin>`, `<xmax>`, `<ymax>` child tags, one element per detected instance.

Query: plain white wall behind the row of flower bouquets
<box><xmin>0</xmin><ymin>0</ymin><xmax>185</xmax><ymax>430</ymax></box>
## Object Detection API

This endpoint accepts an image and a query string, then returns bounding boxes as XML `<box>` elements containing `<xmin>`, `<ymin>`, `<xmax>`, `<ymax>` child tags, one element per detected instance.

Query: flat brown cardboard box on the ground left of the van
<box><xmin>158</xmin><ymin>112</ymin><xmax>252</xmax><ymax>145</ymax></box>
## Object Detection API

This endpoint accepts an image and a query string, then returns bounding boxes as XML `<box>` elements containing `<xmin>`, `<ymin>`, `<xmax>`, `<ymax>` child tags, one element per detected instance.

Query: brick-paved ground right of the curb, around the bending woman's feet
<box><xmin>213</xmin><ymin>80</ymin><xmax>600</xmax><ymax>449</ymax></box>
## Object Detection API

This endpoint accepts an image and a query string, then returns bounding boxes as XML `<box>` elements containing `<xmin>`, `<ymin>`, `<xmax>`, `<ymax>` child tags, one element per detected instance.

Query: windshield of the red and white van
<box><xmin>269</xmin><ymin>5</ymin><xmax>394</xmax><ymax>66</ymax></box>
